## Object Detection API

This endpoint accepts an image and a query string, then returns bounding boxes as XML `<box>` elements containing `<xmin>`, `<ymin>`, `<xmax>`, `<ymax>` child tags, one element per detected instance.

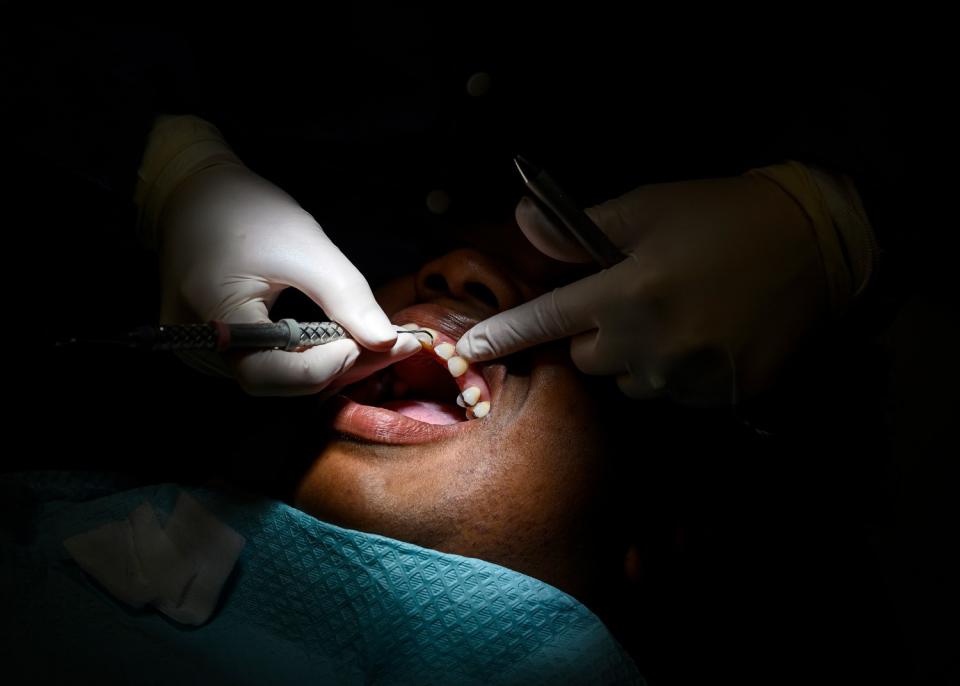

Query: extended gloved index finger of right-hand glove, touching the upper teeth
<box><xmin>457</xmin><ymin>263</ymin><xmax>629</xmax><ymax>362</ymax></box>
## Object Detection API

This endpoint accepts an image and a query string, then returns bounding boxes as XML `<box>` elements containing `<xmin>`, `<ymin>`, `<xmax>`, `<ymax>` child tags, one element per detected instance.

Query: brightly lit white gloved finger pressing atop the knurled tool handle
<box><xmin>283</xmin><ymin>231</ymin><xmax>397</xmax><ymax>351</ymax></box>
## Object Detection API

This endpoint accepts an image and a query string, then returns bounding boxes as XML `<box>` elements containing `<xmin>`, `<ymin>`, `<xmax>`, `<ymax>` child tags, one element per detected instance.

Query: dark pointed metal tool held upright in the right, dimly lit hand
<box><xmin>513</xmin><ymin>155</ymin><xmax>626</xmax><ymax>269</ymax></box>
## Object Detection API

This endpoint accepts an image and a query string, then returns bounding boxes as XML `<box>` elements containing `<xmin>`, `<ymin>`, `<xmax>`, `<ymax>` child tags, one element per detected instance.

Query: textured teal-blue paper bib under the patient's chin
<box><xmin>0</xmin><ymin>472</ymin><xmax>644</xmax><ymax>685</ymax></box>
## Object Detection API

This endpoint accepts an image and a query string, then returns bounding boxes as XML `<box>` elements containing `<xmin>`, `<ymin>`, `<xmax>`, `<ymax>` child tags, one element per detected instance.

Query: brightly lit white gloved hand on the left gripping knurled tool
<box><xmin>138</xmin><ymin>117</ymin><xmax>420</xmax><ymax>395</ymax></box>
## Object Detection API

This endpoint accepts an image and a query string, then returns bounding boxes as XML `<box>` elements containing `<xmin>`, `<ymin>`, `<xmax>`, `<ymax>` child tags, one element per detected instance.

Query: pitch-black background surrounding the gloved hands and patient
<box><xmin>3</xmin><ymin>10</ymin><xmax>958</xmax><ymax>684</ymax></box>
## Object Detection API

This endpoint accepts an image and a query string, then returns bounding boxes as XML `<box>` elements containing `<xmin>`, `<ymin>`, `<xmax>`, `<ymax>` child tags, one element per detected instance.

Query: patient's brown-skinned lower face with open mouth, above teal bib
<box><xmin>295</xmin><ymin>242</ymin><xmax>616</xmax><ymax>593</ymax></box>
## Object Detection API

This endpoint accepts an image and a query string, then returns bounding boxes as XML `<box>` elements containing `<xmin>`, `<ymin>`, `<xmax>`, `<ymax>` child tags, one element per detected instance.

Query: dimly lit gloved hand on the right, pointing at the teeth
<box><xmin>457</xmin><ymin>162</ymin><xmax>869</xmax><ymax>405</ymax></box>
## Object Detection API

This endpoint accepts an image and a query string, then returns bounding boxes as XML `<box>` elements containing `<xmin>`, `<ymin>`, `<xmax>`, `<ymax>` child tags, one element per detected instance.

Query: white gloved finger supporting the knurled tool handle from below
<box><xmin>228</xmin><ymin>338</ymin><xmax>360</xmax><ymax>395</ymax></box>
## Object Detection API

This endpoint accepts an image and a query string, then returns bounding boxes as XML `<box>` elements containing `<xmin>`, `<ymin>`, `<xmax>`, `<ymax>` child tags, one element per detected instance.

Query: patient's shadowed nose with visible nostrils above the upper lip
<box><xmin>417</xmin><ymin>249</ymin><xmax>522</xmax><ymax>313</ymax></box>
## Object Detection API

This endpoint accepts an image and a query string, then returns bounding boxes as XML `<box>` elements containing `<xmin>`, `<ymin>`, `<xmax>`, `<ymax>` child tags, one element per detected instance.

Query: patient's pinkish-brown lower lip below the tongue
<box><xmin>331</xmin><ymin>364</ymin><xmax>507</xmax><ymax>445</ymax></box>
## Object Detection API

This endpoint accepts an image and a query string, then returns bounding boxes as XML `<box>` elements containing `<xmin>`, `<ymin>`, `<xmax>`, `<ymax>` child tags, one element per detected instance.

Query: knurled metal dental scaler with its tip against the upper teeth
<box><xmin>58</xmin><ymin>319</ymin><xmax>433</xmax><ymax>352</ymax></box>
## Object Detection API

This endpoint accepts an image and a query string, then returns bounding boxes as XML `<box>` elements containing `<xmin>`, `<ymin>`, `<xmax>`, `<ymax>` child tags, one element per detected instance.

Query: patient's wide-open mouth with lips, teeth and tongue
<box><xmin>333</xmin><ymin>305</ymin><xmax>506</xmax><ymax>444</ymax></box>
